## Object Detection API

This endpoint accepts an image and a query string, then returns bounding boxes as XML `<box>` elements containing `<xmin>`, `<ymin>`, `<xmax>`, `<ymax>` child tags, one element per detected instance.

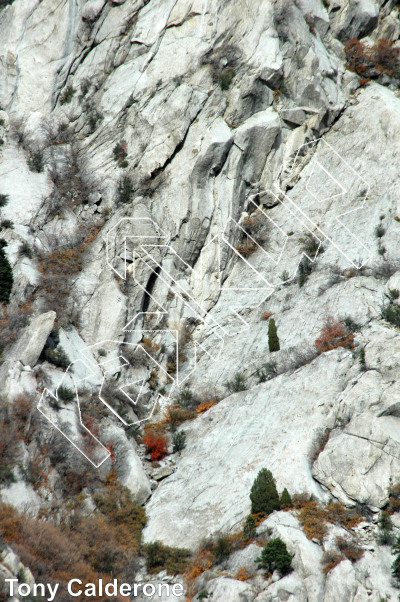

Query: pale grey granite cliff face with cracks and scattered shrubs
<box><xmin>0</xmin><ymin>0</ymin><xmax>400</xmax><ymax>602</ymax></box>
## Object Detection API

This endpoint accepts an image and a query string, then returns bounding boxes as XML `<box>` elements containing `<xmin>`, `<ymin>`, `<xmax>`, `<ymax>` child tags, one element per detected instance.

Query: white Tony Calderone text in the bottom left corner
<box><xmin>5</xmin><ymin>579</ymin><xmax>184</xmax><ymax>602</ymax></box>
